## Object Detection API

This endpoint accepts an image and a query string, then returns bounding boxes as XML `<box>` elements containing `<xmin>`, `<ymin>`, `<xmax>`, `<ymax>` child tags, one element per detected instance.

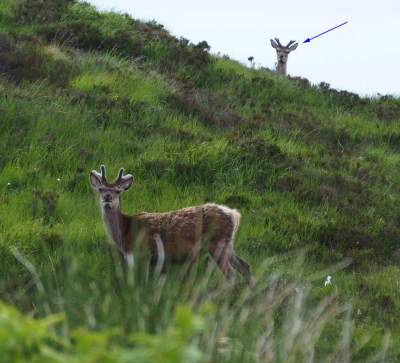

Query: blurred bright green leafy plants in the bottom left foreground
<box><xmin>0</xmin><ymin>302</ymin><xmax>204</xmax><ymax>363</ymax></box>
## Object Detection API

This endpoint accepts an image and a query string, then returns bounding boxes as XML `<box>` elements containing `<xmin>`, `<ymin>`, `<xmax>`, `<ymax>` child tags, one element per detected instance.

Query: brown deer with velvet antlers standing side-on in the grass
<box><xmin>90</xmin><ymin>165</ymin><xmax>251</xmax><ymax>283</ymax></box>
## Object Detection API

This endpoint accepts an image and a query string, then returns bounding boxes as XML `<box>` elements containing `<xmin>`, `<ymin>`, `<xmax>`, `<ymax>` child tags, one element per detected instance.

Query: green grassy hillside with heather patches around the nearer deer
<box><xmin>0</xmin><ymin>0</ymin><xmax>400</xmax><ymax>362</ymax></box>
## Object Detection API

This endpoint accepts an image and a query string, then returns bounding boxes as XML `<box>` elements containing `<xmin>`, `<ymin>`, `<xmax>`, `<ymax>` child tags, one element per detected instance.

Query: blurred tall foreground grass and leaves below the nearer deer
<box><xmin>0</xmin><ymin>248</ymin><xmax>389</xmax><ymax>362</ymax></box>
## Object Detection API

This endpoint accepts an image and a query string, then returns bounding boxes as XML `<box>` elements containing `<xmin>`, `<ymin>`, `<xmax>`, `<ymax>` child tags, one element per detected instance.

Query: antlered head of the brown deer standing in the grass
<box><xmin>90</xmin><ymin>165</ymin><xmax>133</xmax><ymax>211</ymax></box>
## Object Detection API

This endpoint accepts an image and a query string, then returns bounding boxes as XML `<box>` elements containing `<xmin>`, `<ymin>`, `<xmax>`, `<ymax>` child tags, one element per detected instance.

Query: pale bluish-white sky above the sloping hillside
<box><xmin>90</xmin><ymin>0</ymin><xmax>400</xmax><ymax>96</ymax></box>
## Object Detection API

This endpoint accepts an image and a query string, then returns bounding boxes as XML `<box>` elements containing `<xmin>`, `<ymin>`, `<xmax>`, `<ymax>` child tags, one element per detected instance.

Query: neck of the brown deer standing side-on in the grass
<box><xmin>102</xmin><ymin>208</ymin><xmax>129</xmax><ymax>253</ymax></box>
